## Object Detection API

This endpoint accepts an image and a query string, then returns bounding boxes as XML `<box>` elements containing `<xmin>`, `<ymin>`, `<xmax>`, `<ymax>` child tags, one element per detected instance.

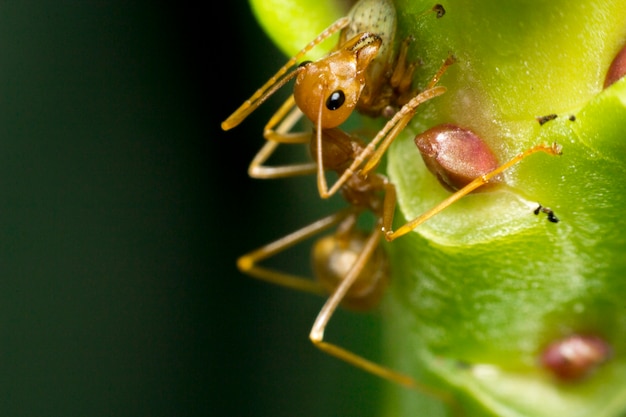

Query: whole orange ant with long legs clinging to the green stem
<box><xmin>222</xmin><ymin>0</ymin><xmax>559</xmax><ymax>410</ymax></box>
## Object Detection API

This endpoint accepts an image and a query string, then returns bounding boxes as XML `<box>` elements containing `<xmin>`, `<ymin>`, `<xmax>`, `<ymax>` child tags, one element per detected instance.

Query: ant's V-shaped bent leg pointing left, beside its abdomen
<box><xmin>237</xmin><ymin>209</ymin><xmax>354</xmax><ymax>295</ymax></box>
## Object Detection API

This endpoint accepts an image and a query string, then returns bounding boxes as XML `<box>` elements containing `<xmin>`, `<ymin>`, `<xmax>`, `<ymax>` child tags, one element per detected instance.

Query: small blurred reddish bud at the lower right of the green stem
<box><xmin>541</xmin><ymin>334</ymin><xmax>612</xmax><ymax>382</ymax></box>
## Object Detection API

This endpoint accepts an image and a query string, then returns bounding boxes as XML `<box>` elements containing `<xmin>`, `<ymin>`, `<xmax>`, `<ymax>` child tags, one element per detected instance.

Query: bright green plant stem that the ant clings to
<box><xmin>246</xmin><ymin>0</ymin><xmax>626</xmax><ymax>417</ymax></box>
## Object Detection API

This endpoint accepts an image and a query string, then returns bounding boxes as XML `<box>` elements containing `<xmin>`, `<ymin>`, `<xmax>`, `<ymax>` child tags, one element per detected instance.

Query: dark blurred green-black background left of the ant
<box><xmin>0</xmin><ymin>0</ymin><xmax>384</xmax><ymax>417</ymax></box>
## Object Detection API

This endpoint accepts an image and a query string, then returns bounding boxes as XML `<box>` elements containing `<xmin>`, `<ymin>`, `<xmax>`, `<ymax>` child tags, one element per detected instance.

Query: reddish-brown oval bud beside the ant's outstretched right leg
<box><xmin>415</xmin><ymin>124</ymin><xmax>498</xmax><ymax>191</ymax></box>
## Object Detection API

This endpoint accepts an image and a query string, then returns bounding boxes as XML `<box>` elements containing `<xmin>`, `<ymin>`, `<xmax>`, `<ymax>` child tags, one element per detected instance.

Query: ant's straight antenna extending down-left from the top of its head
<box><xmin>222</xmin><ymin>17</ymin><xmax>350</xmax><ymax>130</ymax></box>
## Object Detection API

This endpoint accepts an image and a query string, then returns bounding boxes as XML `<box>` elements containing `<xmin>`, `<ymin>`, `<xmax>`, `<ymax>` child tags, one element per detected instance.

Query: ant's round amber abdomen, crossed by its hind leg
<box><xmin>312</xmin><ymin>231</ymin><xmax>389</xmax><ymax>311</ymax></box>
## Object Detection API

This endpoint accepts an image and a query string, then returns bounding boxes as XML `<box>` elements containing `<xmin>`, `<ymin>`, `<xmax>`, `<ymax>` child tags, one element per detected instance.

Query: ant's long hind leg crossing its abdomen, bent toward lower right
<box><xmin>309</xmin><ymin>223</ymin><xmax>455</xmax><ymax>404</ymax></box>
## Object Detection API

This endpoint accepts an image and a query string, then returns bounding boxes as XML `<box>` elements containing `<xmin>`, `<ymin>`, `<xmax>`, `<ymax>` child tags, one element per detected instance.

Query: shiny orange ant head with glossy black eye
<box><xmin>294</xmin><ymin>33</ymin><xmax>382</xmax><ymax>129</ymax></box>
